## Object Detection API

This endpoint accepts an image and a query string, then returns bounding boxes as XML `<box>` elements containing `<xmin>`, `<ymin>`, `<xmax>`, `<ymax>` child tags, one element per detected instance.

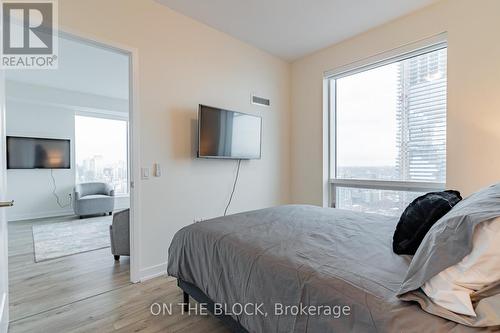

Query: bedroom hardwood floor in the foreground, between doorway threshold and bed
<box><xmin>9</xmin><ymin>277</ymin><xmax>230</xmax><ymax>333</ymax></box>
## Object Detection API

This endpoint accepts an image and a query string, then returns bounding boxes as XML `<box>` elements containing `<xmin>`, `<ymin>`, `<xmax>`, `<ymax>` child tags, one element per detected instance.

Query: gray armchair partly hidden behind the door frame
<box><xmin>109</xmin><ymin>209</ymin><xmax>130</xmax><ymax>260</ymax></box>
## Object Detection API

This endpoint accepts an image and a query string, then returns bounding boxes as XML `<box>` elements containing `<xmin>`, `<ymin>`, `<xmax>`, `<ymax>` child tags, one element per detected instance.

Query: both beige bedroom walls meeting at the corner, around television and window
<box><xmin>53</xmin><ymin>0</ymin><xmax>500</xmax><ymax>274</ymax></box>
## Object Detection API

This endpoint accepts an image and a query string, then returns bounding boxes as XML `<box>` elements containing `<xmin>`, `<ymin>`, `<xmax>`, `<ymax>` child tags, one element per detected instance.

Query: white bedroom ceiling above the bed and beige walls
<box><xmin>157</xmin><ymin>0</ymin><xmax>437</xmax><ymax>60</ymax></box>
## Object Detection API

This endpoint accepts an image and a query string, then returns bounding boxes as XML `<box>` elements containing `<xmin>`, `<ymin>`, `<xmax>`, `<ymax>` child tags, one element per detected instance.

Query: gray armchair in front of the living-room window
<box><xmin>73</xmin><ymin>183</ymin><xmax>115</xmax><ymax>218</ymax></box>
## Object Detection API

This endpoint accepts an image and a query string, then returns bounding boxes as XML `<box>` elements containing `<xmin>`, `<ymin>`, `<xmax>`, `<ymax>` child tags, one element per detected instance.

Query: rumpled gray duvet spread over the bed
<box><xmin>168</xmin><ymin>205</ymin><xmax>492</xmax><ymax>333</ymax></box>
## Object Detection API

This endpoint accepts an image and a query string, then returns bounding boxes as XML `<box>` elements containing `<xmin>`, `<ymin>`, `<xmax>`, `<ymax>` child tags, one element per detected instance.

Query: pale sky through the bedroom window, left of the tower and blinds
<box><xmin>332</xmin><ymin>63</ymin><xmax>398</xmax><ymax>167</ymax></box>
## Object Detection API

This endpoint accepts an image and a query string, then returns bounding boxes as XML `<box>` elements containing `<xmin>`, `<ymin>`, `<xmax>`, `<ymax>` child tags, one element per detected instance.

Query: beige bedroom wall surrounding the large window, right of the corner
<box><xmin>291</xmin><ymin>0</ymin><xmax>500</xmax><ymax>205</ymax></box>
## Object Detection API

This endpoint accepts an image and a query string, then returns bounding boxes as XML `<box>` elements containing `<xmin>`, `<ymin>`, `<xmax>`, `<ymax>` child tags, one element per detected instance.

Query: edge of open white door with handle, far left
<box><xmin>0</xmin><ymin>70</ymin><xmax>11</xmax><ymax>333</ymax></box>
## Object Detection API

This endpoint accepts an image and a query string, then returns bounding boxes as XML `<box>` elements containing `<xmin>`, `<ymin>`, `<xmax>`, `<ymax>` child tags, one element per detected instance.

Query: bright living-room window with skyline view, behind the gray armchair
<box><xmin>75</xmin><ymin>116</ymin><xmax>128</xmax><ymax>195</ymax></box>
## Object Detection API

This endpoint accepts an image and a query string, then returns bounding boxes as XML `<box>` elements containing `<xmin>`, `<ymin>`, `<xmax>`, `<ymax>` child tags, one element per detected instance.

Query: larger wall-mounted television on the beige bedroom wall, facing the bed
<box><xmin>198</xmin><ymin>105</ymin><xmax>262</xmax><ymax>159</ymax></box>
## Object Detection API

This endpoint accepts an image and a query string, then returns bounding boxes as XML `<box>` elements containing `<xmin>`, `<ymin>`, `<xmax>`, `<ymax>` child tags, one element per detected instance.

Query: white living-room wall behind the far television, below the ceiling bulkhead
<box><xmin>6</xmin><ymin>100</ymin><xmax>75</xmax><ymax>221</ymax></box>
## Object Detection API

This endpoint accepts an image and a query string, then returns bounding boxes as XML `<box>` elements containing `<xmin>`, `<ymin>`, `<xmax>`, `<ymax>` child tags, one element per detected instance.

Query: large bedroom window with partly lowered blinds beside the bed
<box><xmin>328</xmin><ymin>45</ymin><xmax>447</xmax><ymax>215</ymax></box>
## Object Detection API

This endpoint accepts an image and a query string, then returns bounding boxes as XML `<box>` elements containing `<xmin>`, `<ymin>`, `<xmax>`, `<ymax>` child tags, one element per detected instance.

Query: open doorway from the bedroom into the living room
<box><xmin>1</xmin><ymin>33</ymin><xmax>138</xmax><ymax>322</ymax></box>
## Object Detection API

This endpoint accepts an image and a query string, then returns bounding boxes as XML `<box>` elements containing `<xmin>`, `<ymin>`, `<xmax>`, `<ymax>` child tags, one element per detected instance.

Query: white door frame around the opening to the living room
<box><xmin>58</xmin><ymin>25</ymin><xmax>141</xmax><ymax>283</ymax></box>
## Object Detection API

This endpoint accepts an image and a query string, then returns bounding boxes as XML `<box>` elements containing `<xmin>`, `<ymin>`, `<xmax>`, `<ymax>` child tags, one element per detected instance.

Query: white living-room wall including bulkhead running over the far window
<box><xmin>6</xmin><ymin>81</ymin><xmax>129</xmax><ymax>221</ymax></box>
